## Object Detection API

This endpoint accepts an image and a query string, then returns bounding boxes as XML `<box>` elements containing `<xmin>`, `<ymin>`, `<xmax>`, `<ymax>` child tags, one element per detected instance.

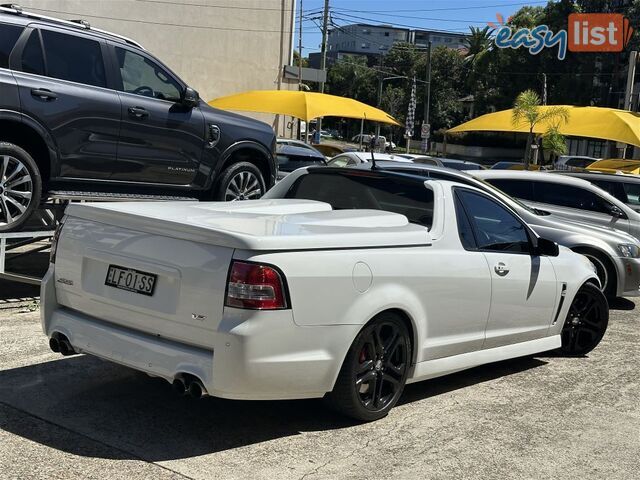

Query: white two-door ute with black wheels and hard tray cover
<box><xmin>42</xmin><ymin>167</ymin><xmax>609</xmax><ymax>421</ymax></box>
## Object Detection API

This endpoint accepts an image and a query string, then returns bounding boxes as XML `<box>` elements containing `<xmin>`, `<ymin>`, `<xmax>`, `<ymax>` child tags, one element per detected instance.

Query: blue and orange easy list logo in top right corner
<box><xmin>492</xmin><ymin>13</ymin><xmax>633</xmax><ymax>60</ymax></box>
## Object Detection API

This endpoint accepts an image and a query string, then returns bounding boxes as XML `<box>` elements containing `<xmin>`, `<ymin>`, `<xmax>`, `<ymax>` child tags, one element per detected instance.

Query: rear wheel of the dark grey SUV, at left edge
<box><xmin>0</xmin><ymin>142</ymin><xmax>42</xmax><ymax>232</ymax></box>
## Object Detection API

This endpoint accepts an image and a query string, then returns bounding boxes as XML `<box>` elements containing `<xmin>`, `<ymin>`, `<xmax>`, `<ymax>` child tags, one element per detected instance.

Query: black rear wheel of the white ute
<box><xmin>325</xmin><ymin>312</ymin><xmax>411</xmax><ymax>422</ymax></box>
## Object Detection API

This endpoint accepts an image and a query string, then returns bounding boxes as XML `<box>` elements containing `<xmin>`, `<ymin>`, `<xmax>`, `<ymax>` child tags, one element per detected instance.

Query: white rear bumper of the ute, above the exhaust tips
<box><xmin>41</xmin><ymin>269</ymin><xmax>360</xmax><ymax>400</ymax></box>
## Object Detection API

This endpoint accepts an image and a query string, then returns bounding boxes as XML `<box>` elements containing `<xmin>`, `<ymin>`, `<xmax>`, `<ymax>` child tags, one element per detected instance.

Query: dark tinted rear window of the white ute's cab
<box><xmin>285</xmin><ymin>171</ymin><xmax>433</xmax><ymax>228</ymax></box>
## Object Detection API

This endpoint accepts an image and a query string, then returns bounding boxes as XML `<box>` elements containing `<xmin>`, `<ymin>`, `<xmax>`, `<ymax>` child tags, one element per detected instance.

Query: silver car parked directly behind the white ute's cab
<box><xmin>359</xmin><ymin>161</ymin><xmax>640</xmax><ymax>298</ymax></box>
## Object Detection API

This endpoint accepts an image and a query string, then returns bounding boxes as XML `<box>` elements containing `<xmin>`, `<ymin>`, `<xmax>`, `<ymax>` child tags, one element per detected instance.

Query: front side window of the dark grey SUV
<box><xmin>116</xmin><ymin>47</ymin><xmax>182</xmax><ymax>102</ymax></box>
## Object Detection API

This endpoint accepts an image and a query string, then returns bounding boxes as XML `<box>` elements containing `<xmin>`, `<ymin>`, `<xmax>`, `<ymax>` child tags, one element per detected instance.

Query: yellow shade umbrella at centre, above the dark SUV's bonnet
<box><xmin>209</xmin><ymin>90</ymin><xmax>400</xmax><ymax>125</ymax></box>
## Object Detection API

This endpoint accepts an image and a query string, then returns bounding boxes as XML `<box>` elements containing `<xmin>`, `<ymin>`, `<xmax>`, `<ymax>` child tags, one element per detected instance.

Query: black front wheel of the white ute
<box><xmin>560</xmin><ymin>283</ymin><xmax>609</xmax><ymax>356</ymax></box>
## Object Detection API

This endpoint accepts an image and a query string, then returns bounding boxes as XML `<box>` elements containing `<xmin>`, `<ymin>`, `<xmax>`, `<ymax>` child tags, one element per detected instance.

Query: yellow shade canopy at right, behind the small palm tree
<box><xmin>447</xmin><ymin>105</ymin><xmax>640</xmax><ymax>146</ymax></box>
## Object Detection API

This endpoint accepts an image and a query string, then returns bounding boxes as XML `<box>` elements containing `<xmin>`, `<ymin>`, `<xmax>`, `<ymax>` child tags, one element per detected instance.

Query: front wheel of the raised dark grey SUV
<box><xmin>215</xmin><ymin>162</ymin><xmax>267</xmax><ymax>202</ymax></box>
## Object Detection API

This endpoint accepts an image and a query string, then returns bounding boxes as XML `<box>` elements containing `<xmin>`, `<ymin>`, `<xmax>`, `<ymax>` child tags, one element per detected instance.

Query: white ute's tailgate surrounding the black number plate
<box><xmin>55</xmin><ymin>217</ymin><xmax>233</xmax><ymax>347</ymax></box>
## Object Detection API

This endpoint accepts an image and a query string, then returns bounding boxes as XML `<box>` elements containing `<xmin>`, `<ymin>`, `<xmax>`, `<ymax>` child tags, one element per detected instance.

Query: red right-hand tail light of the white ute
<box><xmin>225</xmin><ymin>261</ymin><xmax>288</xmax><ymax>310</ymax></box>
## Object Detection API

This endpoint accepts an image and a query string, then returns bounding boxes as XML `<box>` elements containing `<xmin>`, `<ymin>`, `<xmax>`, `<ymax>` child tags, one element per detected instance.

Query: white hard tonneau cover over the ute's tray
<box><xmin>66</xmin><ymin>200</ymin><xmax>430</xmax><ymax>251</ymax></box>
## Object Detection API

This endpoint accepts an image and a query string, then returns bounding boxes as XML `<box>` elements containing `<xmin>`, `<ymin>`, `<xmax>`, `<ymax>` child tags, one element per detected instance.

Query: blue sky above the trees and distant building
<box><xmin>294</xmin><ymin>0</ymin><xmax>547</xmax><ymax>57</ymax></box>
